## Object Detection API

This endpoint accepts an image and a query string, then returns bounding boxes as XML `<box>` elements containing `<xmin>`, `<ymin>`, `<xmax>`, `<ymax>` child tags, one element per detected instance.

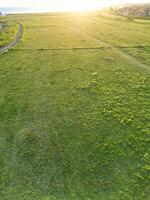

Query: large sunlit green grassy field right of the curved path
<box><xmin>0</xmin><ymin>13</ymin><xmax>150</xmax><ymax>200</ymax></box>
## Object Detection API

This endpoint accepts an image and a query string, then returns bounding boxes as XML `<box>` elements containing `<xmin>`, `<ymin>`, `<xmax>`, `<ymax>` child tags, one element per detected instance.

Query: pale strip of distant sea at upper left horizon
<box><xmin>0</xmin><ymin>7</ymin><xmax>52</xmax><ymax>14</ymax></box>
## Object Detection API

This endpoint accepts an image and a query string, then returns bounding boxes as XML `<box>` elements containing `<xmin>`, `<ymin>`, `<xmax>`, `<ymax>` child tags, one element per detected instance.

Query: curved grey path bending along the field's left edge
<box><xmin>0</xmin><ymin>22</ymin><xmax>23</xmax><ymax>53</ymax></box>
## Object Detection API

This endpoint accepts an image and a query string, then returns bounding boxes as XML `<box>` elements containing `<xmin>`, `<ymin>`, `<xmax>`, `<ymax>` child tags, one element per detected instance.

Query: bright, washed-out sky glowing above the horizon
<box><xmin>0</xmin><ymin>0</ymin><xmax>150</xmax><ymax>11</ymax></box>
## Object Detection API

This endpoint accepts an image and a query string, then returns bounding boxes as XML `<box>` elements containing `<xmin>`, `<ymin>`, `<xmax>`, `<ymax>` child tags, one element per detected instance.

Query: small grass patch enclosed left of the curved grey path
<box><xmin>0</xmin><ymin>20</ymin><xmax>18</xmax><ymax>47</ymax></box>
